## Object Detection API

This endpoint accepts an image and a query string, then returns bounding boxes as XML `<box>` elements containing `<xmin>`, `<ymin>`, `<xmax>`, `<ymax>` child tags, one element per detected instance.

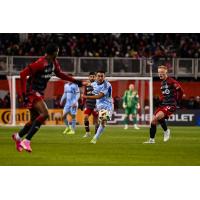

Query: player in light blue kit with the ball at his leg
<box><xmin>83</xmin><ymin>71</ymin><xmax>113</xmax><ymax>144</ymax></box>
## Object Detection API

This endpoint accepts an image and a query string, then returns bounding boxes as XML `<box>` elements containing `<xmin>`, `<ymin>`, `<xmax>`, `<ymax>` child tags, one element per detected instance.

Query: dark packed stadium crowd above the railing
<box><xmin>0</xmin><ymin>33</ymin><xmax>200</xmax><ymax>58</ymax></box>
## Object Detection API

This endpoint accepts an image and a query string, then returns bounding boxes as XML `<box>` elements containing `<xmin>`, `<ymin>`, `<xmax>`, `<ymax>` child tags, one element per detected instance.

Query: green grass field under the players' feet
<box><xmin>0</xmin><ymin>127</ymin><xmax>200</xmax><ymax>166</ymax></box>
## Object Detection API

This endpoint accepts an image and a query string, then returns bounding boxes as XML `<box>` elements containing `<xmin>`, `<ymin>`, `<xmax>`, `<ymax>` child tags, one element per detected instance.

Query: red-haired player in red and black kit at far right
<box><xmin>144</xmin><ymin>65</ymin><xmax>183</xmax><ymax>144</ymax></box>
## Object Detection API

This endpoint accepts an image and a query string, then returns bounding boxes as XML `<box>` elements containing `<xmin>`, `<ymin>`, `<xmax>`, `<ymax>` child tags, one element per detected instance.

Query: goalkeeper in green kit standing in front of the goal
<box><xmin>123</xmin><ymin>84</ymin><xmax>140</xmax><ymax>129</ymax></box>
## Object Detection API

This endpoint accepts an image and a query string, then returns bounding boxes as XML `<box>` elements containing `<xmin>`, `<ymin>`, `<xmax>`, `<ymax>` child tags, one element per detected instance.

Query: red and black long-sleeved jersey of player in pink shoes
<box><xmin>20</xmin><ymin>56</ymin><xmax>76</xmax><ymax>95</ymax></box>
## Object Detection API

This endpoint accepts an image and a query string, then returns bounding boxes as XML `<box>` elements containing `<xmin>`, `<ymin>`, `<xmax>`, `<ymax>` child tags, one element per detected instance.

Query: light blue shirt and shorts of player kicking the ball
<box><xmin>91</xmin><ymin>80</ymin><xmax>113</xmax><ymax>112</ymax></box>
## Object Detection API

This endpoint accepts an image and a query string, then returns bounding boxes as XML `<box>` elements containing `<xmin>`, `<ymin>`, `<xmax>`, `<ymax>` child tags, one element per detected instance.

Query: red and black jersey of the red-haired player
<box><xmin>160</xmin><ymin>77</ymin><xmax>183</xmax><ymax>106</ymax></box>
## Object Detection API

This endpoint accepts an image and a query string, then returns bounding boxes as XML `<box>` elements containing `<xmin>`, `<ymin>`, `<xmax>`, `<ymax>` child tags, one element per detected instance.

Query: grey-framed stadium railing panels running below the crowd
<box><xmin>0</xmin><ymin>56</ymin><xmax>200</xmax><ymax>78</ymax></box>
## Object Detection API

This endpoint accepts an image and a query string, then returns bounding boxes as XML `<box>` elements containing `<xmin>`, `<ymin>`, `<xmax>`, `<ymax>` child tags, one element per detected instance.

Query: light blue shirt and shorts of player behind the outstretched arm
<box><xmin>60</xmin><ymin>83</ymin><xmax>80</xmax><ymax>115</ymax></box>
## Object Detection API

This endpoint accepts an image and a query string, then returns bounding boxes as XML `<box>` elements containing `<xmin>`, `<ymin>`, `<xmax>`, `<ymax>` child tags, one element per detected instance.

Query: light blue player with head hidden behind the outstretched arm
<box><xmin>60</xmin><ymin>74</ymin><xmax>80</xmax><ymax>134</ymax></box>
